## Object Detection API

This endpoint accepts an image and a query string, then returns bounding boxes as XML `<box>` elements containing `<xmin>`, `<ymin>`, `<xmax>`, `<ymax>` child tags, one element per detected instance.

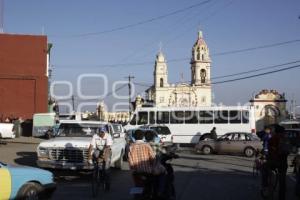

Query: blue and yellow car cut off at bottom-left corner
<box><xmin>0</xmin><ymin>162</ymin><xmax>56</xmax><ymax>199</ymax></box>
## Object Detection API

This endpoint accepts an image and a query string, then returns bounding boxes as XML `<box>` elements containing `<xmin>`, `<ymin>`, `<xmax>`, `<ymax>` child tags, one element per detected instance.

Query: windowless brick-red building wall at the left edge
<box><xmin>0</xmin><ymin>34</ymin><xmax>48</xmax><ymax>119</ymax></box>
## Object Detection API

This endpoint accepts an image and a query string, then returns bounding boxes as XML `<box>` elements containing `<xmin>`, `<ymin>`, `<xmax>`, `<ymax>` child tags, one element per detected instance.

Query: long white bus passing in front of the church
<box><xmin>124</xmin><ymin>106</ymin><xmax>256</xmax><ymax>144</ymax></box>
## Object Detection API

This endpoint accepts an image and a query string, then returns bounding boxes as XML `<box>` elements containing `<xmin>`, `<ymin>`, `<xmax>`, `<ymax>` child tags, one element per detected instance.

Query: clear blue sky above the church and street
<box><xmin>0</xmin><ymin>0</ymin><xmax>300</xmax><ymax>114</ymax></box>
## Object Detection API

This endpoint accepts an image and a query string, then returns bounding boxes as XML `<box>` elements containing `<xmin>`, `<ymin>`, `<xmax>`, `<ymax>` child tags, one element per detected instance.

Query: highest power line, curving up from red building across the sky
<box><xmin>49</xmin><ymin>0</ymin><xmax>212</xmax><ymax>37</ymax></box>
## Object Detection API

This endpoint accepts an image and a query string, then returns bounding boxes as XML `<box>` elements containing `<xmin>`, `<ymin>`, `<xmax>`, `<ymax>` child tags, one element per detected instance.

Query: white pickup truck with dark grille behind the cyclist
<box><xmin>37</xmin><ymin>120</ymin><xmax>126</xmax><ymax>170</ymax></box>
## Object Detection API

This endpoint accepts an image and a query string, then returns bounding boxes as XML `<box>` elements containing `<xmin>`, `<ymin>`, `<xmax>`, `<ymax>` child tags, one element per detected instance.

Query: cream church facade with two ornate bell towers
<box><xmin>146</xmin><ymin>31</ymin><xmax>212</xmax><ymax>107</ymax></box>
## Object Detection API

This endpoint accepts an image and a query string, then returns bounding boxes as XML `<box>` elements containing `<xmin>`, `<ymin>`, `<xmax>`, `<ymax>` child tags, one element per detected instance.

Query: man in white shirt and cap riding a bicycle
<box><xmin>88</xmin><ymin>127</ymin><xmax>113</xmax><ymax>190</ymax></box>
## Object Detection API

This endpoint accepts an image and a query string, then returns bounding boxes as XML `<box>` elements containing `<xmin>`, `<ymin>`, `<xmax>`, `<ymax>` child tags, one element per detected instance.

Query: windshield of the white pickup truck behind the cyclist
<box><xmin>58</xmin><ymin>123</ymin><xmax>104</xmax><ymax>137</ymax></box>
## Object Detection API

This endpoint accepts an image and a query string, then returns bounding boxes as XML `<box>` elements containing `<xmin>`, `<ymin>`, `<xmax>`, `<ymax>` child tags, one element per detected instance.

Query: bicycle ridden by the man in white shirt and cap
<box><xmin>92</xmin><ymin>159</ymin><xmax>110</xmax><ymax>198</ymax></box>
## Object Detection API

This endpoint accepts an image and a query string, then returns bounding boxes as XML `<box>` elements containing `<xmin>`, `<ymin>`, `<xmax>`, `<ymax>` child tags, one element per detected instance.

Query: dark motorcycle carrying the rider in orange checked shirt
<box><xmin>130</xmin><ymin>145</ymin><xmax>179</xmax><ymax>200</ymax></box>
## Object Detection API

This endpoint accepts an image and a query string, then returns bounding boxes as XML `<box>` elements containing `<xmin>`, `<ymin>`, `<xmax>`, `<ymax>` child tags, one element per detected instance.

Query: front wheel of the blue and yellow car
<box><xmin>16</xmin><ymin>183</ymin><xmax>42</xmax><ymax>200</ymax></box>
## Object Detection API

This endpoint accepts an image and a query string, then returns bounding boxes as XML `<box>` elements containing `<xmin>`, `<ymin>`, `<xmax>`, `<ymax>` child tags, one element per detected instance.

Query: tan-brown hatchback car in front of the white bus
<box><xmin>195</xmin><ymin>132</ymin><xmax>262</xmax><ymax>157</ymax></box>
